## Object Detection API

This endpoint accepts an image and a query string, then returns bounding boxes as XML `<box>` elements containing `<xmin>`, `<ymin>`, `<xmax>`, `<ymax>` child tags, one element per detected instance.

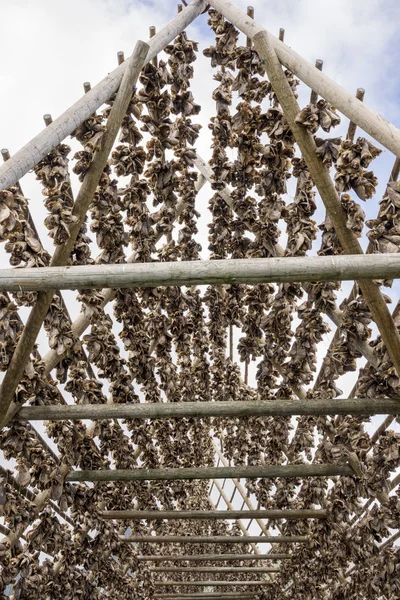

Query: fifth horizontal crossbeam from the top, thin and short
<box><xmin>118</xmin><ymin>535</ymin><xmax>308</xmax><ymax>544</ymax></box>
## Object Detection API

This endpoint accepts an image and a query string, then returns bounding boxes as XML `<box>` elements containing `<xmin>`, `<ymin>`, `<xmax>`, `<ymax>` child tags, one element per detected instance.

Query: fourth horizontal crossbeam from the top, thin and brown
<box><xmin>99</xmin><ymin>509</ymin><xmax>327</xmax><ymax>521</ymax></box>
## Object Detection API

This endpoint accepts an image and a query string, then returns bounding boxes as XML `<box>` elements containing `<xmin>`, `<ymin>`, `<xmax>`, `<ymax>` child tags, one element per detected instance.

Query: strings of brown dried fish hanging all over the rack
<box><xmin>0</xmin><ymin>5</ymin><xmax>400</xmax><ymax>600</ymax></box>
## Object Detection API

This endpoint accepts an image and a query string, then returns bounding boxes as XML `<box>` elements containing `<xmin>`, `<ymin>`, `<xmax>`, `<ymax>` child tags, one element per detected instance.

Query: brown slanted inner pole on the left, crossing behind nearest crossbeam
<box><xmin>0</xmin><ymin>41</ymin><xmax>149</xmax><ymax>427</ymax></box>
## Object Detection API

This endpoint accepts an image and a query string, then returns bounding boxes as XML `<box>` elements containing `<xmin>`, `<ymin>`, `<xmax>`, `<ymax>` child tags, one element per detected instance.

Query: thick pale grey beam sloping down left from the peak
<box><xmin>0</xmin><ymin>0</ymin><xmax>206</xmax><ymax>190</ymax></box>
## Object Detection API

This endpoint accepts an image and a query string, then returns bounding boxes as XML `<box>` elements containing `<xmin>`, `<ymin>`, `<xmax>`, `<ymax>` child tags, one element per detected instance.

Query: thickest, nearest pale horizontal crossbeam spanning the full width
<box><xmin>0</xmin><ymin>253</ymin><xmax>400</xmax><ymax>292</ymax></box>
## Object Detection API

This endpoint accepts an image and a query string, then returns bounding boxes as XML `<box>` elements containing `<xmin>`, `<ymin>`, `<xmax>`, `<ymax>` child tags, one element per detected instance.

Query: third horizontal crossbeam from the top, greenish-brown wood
<box><xmin>66</xmin><ymin>464</ymin><xmax>354</xmax><ymax>481</ymax></box>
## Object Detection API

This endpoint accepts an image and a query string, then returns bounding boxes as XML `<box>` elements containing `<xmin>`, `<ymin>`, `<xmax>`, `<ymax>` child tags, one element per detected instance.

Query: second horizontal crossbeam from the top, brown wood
<box><xmin>14</xmin><ymin>398</ymin><xmax>400</xmax><ymax>421</ymax></box>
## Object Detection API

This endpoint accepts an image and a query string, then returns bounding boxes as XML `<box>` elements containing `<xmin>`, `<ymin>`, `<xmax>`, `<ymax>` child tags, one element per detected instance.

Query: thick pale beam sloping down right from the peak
<box><xmin>209</xmin><ymin>0</ymin><xmax>400</xmax><ymax>156</ymax></box>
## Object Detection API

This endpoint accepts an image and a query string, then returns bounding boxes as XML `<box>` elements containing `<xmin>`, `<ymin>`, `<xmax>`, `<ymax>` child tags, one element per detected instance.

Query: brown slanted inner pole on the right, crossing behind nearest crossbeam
<box><xmin>253</xmin><ymin>31</ymin><xmax>400</xmax><ymax>376</ymax></box>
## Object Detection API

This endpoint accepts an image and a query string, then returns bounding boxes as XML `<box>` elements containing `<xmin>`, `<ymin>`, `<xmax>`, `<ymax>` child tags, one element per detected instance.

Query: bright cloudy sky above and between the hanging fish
<box><xmin>0</xmin><ymin>0</ymin><xmax>400</xmax><ymax>544</ymax></box>
